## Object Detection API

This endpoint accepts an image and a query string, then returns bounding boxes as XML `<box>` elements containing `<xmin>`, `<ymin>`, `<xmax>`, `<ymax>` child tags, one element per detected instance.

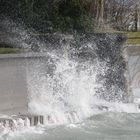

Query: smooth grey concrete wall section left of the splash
<box><xmin>0</xmin><ymin>54</ymin><xmax>46</xmax><ymax>115</ymax></box>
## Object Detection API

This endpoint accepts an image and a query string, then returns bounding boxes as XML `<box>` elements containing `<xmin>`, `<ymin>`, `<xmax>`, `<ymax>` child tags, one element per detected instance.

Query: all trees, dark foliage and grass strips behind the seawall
<box><xmin>0</xmin><ymin>0</ymin><xmax>140</xmax><ymax>54</ymax></box>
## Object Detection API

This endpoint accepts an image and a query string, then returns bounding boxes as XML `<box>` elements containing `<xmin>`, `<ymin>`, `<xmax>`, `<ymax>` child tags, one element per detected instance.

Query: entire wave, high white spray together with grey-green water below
<box><xmin>0</xmin><ymin>20</ymin><xmax>140</xmax><ymax>140</ymax></box>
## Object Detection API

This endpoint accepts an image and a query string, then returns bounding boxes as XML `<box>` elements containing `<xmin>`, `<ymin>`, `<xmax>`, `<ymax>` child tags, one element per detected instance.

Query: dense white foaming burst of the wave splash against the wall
<box><xmin>27</xmin><ymin>38</ymin><xmax>128</xmax><ymax>124</ymax></box>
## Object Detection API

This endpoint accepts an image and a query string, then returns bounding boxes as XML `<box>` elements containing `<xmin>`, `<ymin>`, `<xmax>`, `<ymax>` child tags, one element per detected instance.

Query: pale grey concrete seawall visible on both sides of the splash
<box><xmin>0</xmin><ymin>46</ymin><xmax>140</xmax><ymax>114</ymax></box>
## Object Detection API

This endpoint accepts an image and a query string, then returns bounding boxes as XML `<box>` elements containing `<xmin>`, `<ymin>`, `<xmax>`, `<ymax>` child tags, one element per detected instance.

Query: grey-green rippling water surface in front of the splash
<box><xmin>0</xmin><ymin>112</ymin><xmax>140</xmax><ymax>140</ymax></box>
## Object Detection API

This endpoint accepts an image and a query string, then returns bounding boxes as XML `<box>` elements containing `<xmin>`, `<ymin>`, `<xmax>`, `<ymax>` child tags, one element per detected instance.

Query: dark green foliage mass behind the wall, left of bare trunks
<box><xmin>0</xmin><ymin>0</ymin><xmax>94</xmax><ymax>32</ymax></box>
